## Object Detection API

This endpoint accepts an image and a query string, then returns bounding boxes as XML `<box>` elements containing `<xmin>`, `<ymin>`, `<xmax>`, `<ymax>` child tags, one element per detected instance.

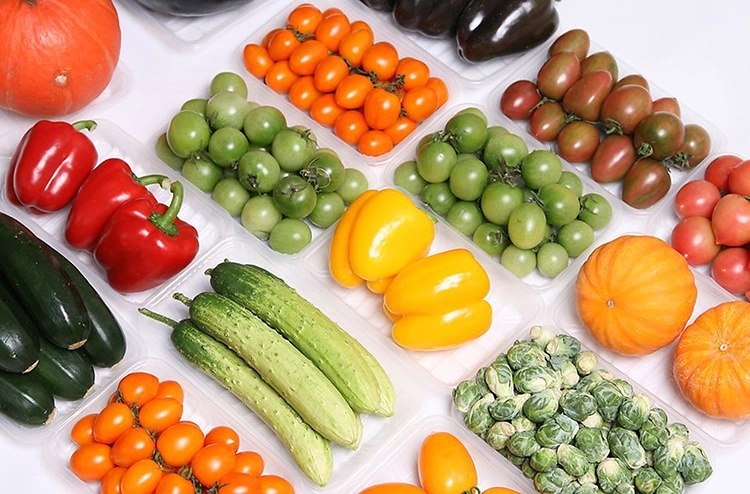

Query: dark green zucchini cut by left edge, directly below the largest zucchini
<box><xmin>0</xmin><ymin>280</ymin><xmax>39</xmax><ymax>374</ymax></box>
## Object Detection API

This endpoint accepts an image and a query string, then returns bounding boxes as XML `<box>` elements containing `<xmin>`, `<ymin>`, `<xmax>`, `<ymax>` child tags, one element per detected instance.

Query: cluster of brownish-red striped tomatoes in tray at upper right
<box><xmin>500</xmin><ymin>29</ymin><xmax>711</xmax><ymax>209</ymax></box>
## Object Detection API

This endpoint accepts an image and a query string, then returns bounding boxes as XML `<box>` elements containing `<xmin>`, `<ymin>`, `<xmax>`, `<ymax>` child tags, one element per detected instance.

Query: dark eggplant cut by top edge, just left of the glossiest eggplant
<box><xmin>393</xmin><ymin>0</ymin><xmax>471</xmax><ymax>38</ymax></box>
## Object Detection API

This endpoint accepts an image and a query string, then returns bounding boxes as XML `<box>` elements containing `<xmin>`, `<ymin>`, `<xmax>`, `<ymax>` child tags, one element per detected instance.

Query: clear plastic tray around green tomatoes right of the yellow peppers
<box><xmin>385</xmin><ymin>104</ymin><xmax>632</xmax><ymax>292</ymax></box>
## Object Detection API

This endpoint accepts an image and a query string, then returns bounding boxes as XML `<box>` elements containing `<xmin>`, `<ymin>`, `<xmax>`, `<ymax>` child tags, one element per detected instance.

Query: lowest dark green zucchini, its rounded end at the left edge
<box><xmin>0</xmin><ymin>372</ymin><xmax>55</xmax><ymax>427</ymax></box>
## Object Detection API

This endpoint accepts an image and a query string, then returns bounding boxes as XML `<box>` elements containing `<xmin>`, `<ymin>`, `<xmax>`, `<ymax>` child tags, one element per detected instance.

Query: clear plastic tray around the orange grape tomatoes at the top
<box><xmin>234</xmin><ymin>0</ymin><xmax>461</xmax><ymax>166</ymax></box>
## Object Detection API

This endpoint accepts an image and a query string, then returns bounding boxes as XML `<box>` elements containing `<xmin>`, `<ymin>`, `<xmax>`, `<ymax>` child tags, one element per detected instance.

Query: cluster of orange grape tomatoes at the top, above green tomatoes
<box><xmin>243</xmin><ymin>3</ymin><xmax>448</xmax><ymax>156</ymax></box>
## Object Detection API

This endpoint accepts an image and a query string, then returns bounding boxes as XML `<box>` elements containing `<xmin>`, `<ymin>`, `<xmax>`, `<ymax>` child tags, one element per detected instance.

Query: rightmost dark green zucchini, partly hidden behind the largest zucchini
<box><xmin>50</xmin><ymin>249</ymin><xmax>127</xmax><ymax>367</ymax></box>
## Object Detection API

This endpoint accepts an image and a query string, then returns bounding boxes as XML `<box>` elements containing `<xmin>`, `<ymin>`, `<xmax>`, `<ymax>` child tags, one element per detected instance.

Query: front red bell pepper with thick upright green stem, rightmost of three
<box><xmin>94</xmin><ymin>182</ymin><xmax>198</xmax><ymax>293</ymax></box>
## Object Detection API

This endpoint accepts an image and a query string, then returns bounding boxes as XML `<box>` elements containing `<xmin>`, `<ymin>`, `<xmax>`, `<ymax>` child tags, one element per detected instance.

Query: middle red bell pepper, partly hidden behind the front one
<box><xmin>65</xmin><ymin>158</ymin><xmax>169</xmax><ymax>251</ymax></box>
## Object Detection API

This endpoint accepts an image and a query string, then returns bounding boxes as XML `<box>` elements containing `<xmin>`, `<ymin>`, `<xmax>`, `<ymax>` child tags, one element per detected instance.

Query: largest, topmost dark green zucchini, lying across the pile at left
<box><xmin>0</xmin><ymin>213</ymin><xmax>91</xmax><ymax>349</ymax></box>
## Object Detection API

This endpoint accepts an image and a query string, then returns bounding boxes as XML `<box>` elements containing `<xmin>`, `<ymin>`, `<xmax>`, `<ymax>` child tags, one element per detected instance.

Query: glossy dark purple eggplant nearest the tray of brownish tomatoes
<box><xmin>456</xmin><ymin>0</ymin><xmax>560</xmax><ymax>62</ymax></box>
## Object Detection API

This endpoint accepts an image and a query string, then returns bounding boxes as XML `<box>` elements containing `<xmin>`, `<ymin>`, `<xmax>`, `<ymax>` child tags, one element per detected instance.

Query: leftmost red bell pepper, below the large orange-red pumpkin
<box><xmin>6</xmin><ymin>120</ymin><xmax>98</xmax><ymax>213</ymax></box>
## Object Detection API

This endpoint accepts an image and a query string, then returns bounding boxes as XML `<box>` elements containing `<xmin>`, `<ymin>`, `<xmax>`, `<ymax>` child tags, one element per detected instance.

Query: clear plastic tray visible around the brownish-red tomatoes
<box><xmin>487</xmin><ymin>38</ymin><xmax>725</xmax><ymax>218</ymax></box>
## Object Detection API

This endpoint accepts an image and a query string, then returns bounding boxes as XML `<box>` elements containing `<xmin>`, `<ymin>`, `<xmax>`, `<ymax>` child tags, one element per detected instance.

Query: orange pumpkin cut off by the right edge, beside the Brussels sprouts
<box><xmin>674</xmin><ymin>300</ymin><xmax>750</xmax><ymax>420</ymax></box>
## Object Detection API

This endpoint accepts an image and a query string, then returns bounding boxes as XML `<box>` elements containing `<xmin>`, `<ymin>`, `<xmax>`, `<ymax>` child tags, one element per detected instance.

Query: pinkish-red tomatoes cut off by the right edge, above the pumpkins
<box><xmin>670</xmin><ymin>154</ymin><xmax>750</xmax><ymax>297</ymax></box>
